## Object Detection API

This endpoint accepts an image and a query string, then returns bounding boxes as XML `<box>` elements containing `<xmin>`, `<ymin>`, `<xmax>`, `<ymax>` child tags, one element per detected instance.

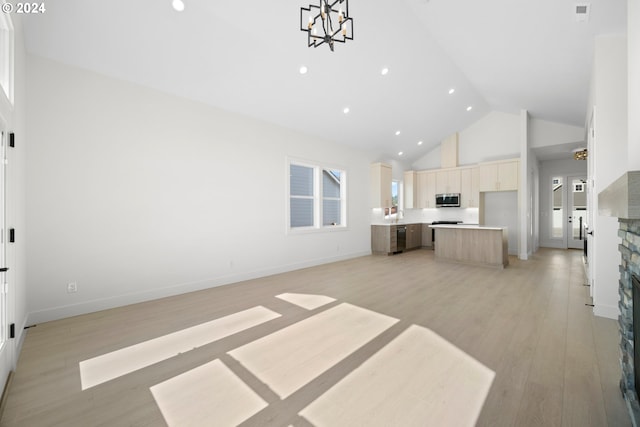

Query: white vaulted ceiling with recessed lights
<box><xmin>22</xmin><ymin>0</ymin><xmax>626</xmax><ymax>161</ymax></box>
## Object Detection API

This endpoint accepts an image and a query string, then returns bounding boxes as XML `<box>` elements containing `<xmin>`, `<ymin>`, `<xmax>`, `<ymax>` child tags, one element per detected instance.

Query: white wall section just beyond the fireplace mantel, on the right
<box><xmin>587</xmin><ymin>35</ymin><xmax>628</xmax><ymax>319</ymax></box>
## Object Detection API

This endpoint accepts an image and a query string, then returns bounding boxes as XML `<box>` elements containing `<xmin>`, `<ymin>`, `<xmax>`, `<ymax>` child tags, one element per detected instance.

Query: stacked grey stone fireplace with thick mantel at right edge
<box><xmin>598</xmin><ymin>171</ymin><xmax>640</xmax><ymax>426</ymax></box>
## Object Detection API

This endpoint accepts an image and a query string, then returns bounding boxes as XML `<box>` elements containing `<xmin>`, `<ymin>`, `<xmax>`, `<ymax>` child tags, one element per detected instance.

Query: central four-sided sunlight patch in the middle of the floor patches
<box><xmin>228</xmin><ymin>303</ymin><xmax>398</xmax><ymax>399</ymax></box>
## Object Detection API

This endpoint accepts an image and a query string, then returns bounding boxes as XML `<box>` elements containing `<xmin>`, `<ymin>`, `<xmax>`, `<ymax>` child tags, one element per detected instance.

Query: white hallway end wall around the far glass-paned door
<box><xmin>539</xmin><ymin>159</ymin><xmax>587</xmax><ymax>248</ymax></box>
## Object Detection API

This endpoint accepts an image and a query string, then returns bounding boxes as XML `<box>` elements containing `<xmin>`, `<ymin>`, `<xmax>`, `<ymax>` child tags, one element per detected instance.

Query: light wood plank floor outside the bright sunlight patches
<box><xmin>0</xmin><ymin>249</ymin><xmax>631</xmax><ymax>427</ymax></box>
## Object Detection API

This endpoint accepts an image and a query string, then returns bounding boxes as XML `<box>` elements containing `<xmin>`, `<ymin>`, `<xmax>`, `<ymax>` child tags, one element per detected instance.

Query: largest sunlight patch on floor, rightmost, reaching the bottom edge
<box><xmin>300</xmin><ymin>325</ymin><xmax>495</xmax><ymax>427</ymax></box>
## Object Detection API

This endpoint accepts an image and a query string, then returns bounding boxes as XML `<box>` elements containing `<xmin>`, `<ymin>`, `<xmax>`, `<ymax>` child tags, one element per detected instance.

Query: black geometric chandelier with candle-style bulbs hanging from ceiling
<box><xmin>300</xmin><ymin>0</ymin><xmax>353</xmax><ymax>52</ymax></box>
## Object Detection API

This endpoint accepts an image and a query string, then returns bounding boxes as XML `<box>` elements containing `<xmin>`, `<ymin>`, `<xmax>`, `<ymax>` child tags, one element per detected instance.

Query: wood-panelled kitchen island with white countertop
<box><xmin>430</xmin><ymin>224</ymin><xmax>509</xmax><ymax>268</ymax></box>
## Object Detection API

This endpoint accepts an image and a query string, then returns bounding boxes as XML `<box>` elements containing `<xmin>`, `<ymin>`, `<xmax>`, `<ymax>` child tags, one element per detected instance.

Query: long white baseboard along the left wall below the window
<box><xmin>25</xmin><ymin>251</ymin><xmax>371</xmax><ymax>325</ymax></box>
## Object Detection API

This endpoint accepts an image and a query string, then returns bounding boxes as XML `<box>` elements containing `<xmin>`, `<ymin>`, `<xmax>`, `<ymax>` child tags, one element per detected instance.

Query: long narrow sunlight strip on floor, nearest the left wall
<box><xmin>80</xmin><ymin>306</ymin><xmax>281</xmax><ymax>390</ymax></box>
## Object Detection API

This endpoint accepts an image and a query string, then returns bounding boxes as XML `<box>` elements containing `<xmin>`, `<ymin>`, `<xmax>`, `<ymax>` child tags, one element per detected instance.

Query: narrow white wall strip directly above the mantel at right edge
<box><xmin>627</xmin><ymin>0</ymin><xmax>640</xmax><ymax>171</ymax></box>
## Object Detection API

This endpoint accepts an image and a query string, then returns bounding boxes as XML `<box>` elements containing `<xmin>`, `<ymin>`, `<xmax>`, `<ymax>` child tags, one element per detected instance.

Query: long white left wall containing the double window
<box><xmin>27</xmin><ymin>56</ymin><xmax>372</xmax><ymax>323</ymax></box>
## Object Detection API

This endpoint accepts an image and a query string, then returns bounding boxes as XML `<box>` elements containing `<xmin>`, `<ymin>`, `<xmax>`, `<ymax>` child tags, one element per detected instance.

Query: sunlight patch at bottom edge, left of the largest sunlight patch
<box><xmin>151</xmin><ymin>360</ymin><xmax>267</xmax><ymax>427</ymax></box>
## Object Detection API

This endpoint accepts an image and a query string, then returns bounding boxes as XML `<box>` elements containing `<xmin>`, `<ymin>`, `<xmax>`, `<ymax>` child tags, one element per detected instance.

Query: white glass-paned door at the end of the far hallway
<box><xmin>567</xmin><ymin>176</ymin><xmax>587</xmax><ymax>249</ymax></box>
